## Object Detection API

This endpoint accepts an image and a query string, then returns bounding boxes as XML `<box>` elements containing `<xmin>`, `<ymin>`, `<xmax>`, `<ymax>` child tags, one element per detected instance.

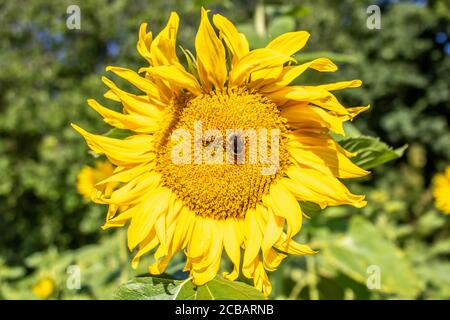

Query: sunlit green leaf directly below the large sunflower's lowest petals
<box><xmin>115</xmin><ymin>276</ymin><xmax>264</xmax><ymax>300</ymax></box>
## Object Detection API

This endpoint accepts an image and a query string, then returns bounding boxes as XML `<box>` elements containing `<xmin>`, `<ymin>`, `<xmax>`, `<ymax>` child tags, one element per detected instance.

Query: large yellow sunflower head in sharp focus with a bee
<box><xmin>73</xmin><ymin>9</ymin><xmax>368</xmax><ymax>295</ymax></box>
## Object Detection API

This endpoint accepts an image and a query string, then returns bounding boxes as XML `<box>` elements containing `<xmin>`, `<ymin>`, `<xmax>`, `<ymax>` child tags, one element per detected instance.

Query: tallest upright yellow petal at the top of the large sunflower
<box><xmin>195</xmin><ymin>8</ymin><xmax>227</xmax><ymax>92</ymax></box>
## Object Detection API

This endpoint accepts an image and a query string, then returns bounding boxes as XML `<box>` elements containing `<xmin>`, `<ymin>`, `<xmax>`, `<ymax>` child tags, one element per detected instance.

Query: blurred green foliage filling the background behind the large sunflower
<box><xmin>0</xmin><ymin>0</ymin><xmax>450</xmax><ymax>299</ymax></box>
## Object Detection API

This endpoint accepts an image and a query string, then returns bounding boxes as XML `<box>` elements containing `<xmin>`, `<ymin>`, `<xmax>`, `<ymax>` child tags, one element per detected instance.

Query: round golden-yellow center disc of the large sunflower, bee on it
<box><xmin>156</xmin><ymin>89</ymin><xmax>288</xmax><ymax>218</ymax></box>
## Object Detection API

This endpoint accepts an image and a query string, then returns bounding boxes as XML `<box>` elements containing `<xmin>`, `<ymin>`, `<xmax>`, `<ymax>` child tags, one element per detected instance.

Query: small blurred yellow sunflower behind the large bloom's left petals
<box><xmin>77</xmin><ymin>161</ymin><xmax>116</xmax><ymax>200</ymax></box>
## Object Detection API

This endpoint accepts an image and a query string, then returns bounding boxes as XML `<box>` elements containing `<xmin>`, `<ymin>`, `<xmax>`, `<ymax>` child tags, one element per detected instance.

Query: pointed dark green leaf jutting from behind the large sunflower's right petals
<box><xmin>338</xmin><ymin>136</ymin><xmax>408</xmax><ymax>169</ymax></box>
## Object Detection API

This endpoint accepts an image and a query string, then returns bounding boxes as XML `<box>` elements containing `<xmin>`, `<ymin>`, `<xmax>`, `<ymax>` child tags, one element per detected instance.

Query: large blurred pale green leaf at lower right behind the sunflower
<box><xmin>322</xmin><ymin>216</ymin><xmax>423</xmax><ymax>298</ymax></box>
